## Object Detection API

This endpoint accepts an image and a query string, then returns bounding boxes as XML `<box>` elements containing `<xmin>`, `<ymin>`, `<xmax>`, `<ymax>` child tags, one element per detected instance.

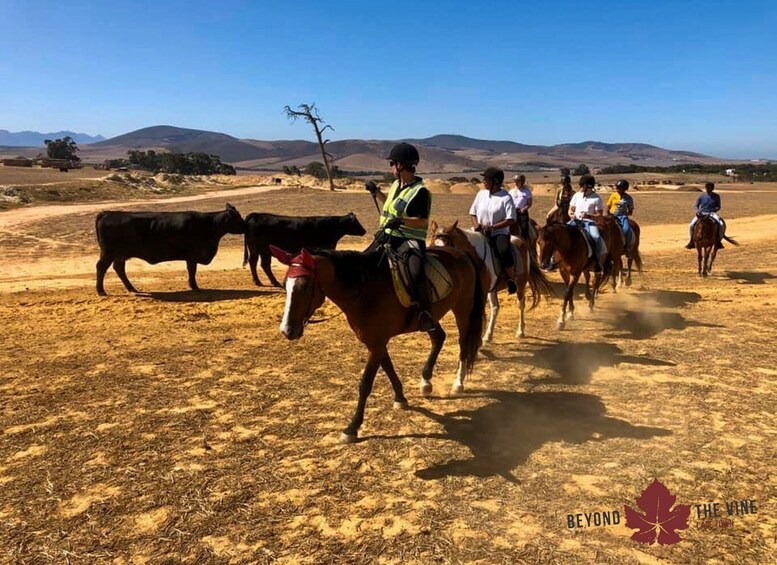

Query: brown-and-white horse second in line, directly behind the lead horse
<box><xmin>429</xmin><ymin>220</ymin><xmax>551</xmax><ymax>343</ymax></box>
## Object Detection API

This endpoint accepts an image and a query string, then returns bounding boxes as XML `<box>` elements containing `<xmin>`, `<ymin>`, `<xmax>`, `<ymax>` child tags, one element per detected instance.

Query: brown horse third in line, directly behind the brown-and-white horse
<box><xmin>537</xmin><ymin>220</ymin><xmax>620</xmax><ymax>329</ymax></box>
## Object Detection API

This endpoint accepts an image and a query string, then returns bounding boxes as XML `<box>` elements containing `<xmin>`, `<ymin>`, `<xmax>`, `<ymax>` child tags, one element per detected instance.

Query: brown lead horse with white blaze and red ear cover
<box><xmin>272</xmin><ymin>247</ymin><xmax>486</xmax><ymax>443</ymax></box>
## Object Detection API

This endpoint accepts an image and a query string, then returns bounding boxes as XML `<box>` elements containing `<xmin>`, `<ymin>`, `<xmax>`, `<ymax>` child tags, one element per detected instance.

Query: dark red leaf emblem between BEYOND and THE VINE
<box><xmin>624</xmin><ymin>479</ymin><xmax>691</xmax><ymax>545</ymax></box>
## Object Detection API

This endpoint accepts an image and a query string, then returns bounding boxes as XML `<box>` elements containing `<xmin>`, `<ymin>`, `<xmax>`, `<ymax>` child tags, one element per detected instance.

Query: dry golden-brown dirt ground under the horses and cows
<box><xmin>0</xmin><ymin>186</ymin><xmax>777</xmax><ymax>563</ymax></box>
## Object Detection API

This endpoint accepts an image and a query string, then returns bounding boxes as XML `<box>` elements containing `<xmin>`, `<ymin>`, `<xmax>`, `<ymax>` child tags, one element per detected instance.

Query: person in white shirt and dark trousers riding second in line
<box><xmin>469</xmin><ymin>167</ymin><xmax>518</xmax><ymax>294</ymax></box>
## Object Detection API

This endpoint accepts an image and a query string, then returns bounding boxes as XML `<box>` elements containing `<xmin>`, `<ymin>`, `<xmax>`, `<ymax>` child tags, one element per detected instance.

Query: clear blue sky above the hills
<box><xmin>0</xmin><ymin>0</ymin><xmax>777</xmax><ymax>158</ymax></box>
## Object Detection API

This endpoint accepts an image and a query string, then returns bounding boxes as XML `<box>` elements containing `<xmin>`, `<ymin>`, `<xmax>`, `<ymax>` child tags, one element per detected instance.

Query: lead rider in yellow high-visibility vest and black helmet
<box><xmin>366</xmin><ymin>143</ymin><xmax>435</xmax><ymax>331</ymax></box>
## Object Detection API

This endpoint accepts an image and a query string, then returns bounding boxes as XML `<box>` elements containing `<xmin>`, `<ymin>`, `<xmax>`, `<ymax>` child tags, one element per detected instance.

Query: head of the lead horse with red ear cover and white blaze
<box><xmin>270</xmin><ymin>245</ymin><xmax>325</xmax><ymax>340</ymax></box>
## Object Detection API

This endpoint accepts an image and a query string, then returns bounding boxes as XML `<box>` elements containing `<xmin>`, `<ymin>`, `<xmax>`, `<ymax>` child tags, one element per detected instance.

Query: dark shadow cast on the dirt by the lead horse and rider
<box><xmin>411</xmin><ymin>390</ymin><xmax>672</xmax><ymax>482</ymax></box>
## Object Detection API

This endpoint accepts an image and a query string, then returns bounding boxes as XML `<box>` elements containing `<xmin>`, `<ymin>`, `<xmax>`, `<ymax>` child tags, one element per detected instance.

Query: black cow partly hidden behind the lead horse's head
<box><xmin>243</xmin><ymin>212</ymin><xmax>367</xmax><ymax>286</ymax></box>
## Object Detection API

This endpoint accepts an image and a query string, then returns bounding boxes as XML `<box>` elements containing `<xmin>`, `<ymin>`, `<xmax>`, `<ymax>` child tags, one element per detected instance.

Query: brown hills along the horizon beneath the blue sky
<box><xmin>0</xmin><ymin>126</ymin><xmax>734</xmax><ymax>173</ymax></box>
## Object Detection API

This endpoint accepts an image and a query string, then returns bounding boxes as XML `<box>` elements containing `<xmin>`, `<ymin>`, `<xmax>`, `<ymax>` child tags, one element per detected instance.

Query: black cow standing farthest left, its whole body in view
<box><xmin>95</xmin><ymin>204</ymin><xmax>245</xmax><ymax>296</ymax></box>
